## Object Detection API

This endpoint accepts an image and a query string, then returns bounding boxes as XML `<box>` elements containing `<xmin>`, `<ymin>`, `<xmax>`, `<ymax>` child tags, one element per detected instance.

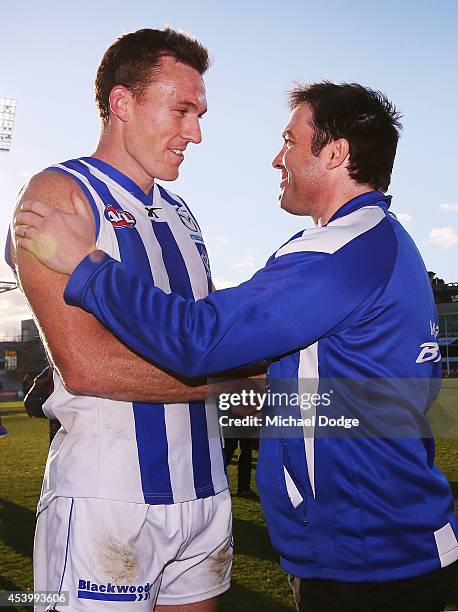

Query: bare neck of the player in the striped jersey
<box><xmin>92</xmin><ymin>132</ymin><xmax>154</xmax><ymax>193</ymax></box>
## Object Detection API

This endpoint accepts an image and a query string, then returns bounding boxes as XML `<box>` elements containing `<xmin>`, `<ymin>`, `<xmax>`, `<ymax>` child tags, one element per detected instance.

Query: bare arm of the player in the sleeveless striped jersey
<box><xmin>11</xmin><ymin>172</ymin><xmax>206</xmax><ymax>403</ymax></box>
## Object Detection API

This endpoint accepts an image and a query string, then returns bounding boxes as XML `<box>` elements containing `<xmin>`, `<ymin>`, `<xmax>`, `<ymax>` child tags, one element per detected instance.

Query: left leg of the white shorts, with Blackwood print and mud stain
<box><xmin>34</xmin><ymin>497</ymin><xmax>166</xmax><ymax>612</ymax></box>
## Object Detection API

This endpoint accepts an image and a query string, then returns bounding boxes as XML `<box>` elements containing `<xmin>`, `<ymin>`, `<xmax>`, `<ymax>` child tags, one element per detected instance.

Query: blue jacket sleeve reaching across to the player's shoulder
<box><xmin>65</xmin><ymin>228</ymin><xmax>393</xmax><ymax>377</ymax></box>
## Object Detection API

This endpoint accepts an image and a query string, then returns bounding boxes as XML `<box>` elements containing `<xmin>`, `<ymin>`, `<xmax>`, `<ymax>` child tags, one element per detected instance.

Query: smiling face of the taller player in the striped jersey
<box><xmin>124</xmin><ymin>57</ymin><xmax>207</xmax><ymax>181</ymax></box>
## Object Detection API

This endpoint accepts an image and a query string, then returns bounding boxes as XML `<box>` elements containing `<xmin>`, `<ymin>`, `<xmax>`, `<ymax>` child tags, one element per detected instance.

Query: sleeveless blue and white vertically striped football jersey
<box><xmin>9</xmin><ymin>157</ymin><xmax>227</xmax><ymax>509</ymax></box>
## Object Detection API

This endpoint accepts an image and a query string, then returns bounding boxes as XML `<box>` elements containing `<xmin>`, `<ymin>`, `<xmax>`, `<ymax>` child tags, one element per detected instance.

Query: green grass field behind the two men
<box><xmin>0</xmin><ymin>381</ymin><xmax>458</xmax><ymax>612</ymax></box>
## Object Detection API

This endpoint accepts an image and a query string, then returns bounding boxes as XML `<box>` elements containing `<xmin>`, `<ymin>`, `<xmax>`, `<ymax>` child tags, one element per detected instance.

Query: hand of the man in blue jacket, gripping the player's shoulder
<box><xmin>14</xmin><ymin>192</ymin><xmax>97</xmax><ymax>275</ymax></box>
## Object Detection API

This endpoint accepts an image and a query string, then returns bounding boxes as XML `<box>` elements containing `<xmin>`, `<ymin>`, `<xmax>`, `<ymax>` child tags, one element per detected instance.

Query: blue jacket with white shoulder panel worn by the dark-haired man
<box><xmin>65</xmin><ymin>192</ymin><xmax>458</xmax><ymax>582</ymax></box>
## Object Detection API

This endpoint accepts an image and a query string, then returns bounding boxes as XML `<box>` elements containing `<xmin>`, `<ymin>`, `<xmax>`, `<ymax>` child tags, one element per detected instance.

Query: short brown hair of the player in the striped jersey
<box><xmin>95</xmin><ymin>28</ymin><xmax>210</xmax><ymax>124</ymax></box>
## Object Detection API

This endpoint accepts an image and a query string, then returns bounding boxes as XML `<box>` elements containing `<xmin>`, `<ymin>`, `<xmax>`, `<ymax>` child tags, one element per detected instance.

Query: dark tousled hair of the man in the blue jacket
<box><xmin>289</xmin><ymin>81</ymin><xmax>402</xmax><ymax>191</ymax></box>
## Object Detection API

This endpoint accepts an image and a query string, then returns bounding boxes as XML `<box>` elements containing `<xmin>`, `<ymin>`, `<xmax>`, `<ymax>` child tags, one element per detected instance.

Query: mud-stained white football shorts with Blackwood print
<box><xmin>34</xmin><ymin>490</ymin><xmax>233</xmax><ymax>612</ymax></box>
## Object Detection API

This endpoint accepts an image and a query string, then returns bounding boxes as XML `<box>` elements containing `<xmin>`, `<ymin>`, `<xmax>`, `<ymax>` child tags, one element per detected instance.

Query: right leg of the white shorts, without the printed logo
<box><xmin>157</xmin><ymin>490</ymin><xmax>233</xmax><ymax>612</ymax></box>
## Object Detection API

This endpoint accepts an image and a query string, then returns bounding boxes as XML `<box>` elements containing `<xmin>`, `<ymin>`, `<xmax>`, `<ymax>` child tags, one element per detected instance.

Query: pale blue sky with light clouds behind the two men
<box><xmin>0</xmin><ymin>0</ymin><xmax>458</xmax><ymax>337</ymax></box>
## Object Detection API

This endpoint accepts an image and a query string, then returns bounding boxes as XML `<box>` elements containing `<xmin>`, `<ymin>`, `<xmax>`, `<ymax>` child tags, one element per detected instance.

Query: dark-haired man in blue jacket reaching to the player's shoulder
<box><xmin>16</xmin><ymin>82</ymin><xmax>458</xmax><ymax>612</ymax></box>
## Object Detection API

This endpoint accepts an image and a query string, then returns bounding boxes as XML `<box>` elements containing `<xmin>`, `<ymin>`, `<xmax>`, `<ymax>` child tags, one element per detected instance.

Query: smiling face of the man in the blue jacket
<box><xmin>272</xmin><ymin>104</ymin><xmax>325</xmax><ymax>215</ymax></box>
